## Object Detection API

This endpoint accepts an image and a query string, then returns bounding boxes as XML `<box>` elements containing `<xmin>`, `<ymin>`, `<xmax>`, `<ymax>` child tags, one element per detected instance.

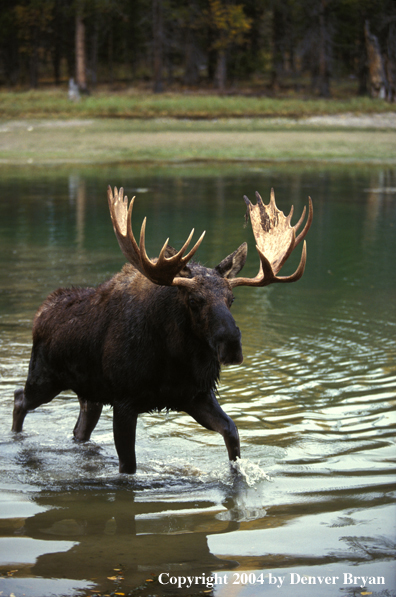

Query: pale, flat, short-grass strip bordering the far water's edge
<box><xmin>0</xmin><ymin>119</ymin><xmax>396</xmax><ymax>165</ymax></box>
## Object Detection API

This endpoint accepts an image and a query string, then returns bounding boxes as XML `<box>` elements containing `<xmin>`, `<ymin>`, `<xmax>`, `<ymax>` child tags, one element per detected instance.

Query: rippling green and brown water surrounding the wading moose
<box><xmin>0</xmin><ymin>165</ymin><xmax>396</xmax><ymax>597</ymax></box>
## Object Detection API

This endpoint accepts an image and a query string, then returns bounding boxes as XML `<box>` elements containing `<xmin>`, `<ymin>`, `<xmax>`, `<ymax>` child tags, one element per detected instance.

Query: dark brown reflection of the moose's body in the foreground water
<box><xmin>15</xmin><ymin>487</ymin><xmax>235</xmax><ymax>587</ymax></box>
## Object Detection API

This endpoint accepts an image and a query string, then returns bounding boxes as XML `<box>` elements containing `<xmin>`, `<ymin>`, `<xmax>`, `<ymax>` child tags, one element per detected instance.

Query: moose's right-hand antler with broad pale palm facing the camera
<box><xmin>229</xmin><ymin>189</ymin><xmax>313</xmax><ymax>288</ymax></box>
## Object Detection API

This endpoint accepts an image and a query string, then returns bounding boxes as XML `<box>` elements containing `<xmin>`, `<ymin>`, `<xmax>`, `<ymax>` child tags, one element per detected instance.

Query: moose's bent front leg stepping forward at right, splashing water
<box><xmin>186</xmin><ymin>392</ymin><xmax>241</xmax><ymax>461</ymax></box>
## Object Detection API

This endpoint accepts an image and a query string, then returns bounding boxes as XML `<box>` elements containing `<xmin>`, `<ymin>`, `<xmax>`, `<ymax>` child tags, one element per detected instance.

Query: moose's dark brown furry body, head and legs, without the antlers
<box><xmin>13</xmin><ymin>245</ymin><xmax>246</xmax><ymax>473</ymax></box>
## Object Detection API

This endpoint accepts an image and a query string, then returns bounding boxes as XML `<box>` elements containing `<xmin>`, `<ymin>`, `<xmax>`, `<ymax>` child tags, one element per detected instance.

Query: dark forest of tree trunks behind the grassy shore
<box><xmin>0</xmin><ymin>0</ymin><xmax>396</xmax><ymax>101</ymax></box>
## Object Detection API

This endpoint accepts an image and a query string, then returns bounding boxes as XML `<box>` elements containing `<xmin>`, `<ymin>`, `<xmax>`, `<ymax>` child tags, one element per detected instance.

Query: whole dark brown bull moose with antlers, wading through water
<box><xmin>12</xmin><ymin>187</ymin><xmax>313</xmax><ymax>473</ymax></box>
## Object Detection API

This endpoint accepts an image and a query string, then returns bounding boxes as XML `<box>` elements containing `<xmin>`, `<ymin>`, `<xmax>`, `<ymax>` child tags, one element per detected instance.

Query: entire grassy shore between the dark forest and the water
<box><xmin>0</xmin><ymin>88</ymin><xmax>396</xmax><ymax>165</ymax></box>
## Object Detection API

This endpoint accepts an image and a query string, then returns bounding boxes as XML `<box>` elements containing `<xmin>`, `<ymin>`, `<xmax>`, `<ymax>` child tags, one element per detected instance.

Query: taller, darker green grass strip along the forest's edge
<box><xmin>0</xmin><ymin>88</ymin><xmax>396</xmax><ymax>119</ymax></box>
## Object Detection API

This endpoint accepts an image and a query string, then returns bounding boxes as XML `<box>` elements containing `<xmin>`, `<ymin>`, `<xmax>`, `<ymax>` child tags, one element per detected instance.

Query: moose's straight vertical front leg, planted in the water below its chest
<box><xmin>113</xmin><ymin>404</ymin><xmax>138</xmax><ymax>475</ymax></box>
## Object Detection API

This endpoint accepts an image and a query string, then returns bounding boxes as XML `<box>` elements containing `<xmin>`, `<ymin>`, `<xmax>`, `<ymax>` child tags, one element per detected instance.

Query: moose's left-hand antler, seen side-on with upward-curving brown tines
<box><xmin>107</xmin><ymin>186</ymin><xmax>205</xmax><ymax>286</ymax></box>
